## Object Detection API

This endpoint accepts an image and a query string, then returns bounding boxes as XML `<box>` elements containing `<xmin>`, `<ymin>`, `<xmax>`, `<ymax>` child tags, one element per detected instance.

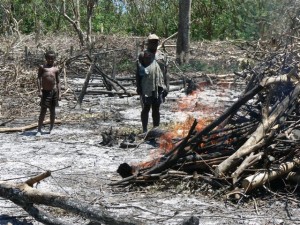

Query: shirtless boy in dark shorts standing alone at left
<box><xmin>36</xmin><ymin>51</ymin><xmax>61</xmax><ymax>136</ymax></box>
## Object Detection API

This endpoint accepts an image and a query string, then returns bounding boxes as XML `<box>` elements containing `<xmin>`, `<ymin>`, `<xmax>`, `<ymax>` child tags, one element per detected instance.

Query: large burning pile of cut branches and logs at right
<box><xmin>112</xmin><ymin>43</ymin><xmax>300</xmax><ymax>198</ymax></box>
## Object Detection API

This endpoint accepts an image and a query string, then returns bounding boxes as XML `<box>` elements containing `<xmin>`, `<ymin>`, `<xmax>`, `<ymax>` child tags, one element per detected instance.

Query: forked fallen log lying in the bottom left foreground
<box><xmin>0</xmin><ymin>171</ymin><xmax>141</xmax><ymax>225</ymax></box>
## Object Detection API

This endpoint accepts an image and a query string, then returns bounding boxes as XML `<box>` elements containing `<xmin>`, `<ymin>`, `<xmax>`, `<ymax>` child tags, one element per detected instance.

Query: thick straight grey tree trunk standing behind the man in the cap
<box><xmin>176</xmin><ymin>0</ymin><xmax>192</xmax><ymax>64</ymax></box>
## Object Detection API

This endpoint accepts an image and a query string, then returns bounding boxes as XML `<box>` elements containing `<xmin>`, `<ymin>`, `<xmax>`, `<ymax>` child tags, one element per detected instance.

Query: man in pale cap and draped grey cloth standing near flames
<box><xmin>136</xmin><ymin>34</ymin><xmax>169</xmax><ymax>133</ymax></box>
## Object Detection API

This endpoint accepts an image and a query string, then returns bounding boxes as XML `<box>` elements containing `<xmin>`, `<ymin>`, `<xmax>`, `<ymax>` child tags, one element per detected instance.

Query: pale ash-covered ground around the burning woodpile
<box><xmin>0</xmin><ymin>80</ymin><xmax>300</xmax><ymax>225</ymax></box>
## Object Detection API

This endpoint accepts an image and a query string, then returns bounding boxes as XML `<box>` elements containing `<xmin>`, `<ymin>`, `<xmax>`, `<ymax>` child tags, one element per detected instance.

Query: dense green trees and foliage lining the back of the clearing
<box><xmin>0</xmin><ymin>0</ymin><xmax>300</xmax><ymax>40</ymax></box>
